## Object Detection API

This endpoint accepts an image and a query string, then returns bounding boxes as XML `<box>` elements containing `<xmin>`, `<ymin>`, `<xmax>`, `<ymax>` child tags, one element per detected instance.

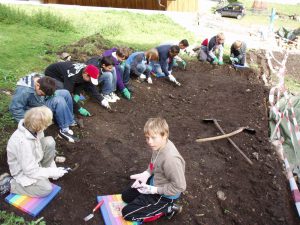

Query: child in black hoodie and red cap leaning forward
<box><xmin>45</xmin><ymin>62</ymin><xmax>110</xmax><ymax>116</ymax></box>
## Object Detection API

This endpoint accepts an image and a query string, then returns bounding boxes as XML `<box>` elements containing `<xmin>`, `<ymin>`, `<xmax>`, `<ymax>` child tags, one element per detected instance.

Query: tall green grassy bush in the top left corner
<box><xmin>0</xmin><ymin>4</ymin><xmax>75</xmax><ymax>32</ymax></box>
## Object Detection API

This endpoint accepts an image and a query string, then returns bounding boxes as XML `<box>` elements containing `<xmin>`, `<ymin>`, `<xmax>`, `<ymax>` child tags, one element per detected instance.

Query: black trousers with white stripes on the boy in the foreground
<box><xmin>122</xmin><ymin>187</ymin><xmax>175</xmax><ymax>222</ymax></box>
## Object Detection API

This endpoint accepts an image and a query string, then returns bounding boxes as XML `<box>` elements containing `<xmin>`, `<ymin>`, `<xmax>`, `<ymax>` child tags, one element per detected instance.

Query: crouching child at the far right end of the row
<box><xmin>230</xmin><ymin>41</ymin><xmax>247</xmax><ymax>66</ymax></box>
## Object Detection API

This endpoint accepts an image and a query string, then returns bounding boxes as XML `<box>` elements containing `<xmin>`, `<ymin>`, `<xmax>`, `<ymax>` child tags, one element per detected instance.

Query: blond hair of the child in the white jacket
<box><xmin>24</xmin><ymin>106</ymin><xmax>53</xmax><ymax>132</ymax></box>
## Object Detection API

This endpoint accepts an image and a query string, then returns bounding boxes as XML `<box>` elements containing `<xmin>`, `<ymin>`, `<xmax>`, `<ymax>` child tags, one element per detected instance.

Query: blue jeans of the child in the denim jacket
<box><xmin>45</xmin><ymin>89</ymin><xmax>74</xmax><ymax>129</ymax></box>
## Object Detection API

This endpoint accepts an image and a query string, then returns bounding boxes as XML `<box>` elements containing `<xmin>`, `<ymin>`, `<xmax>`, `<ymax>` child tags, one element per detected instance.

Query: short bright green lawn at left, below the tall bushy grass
<box><xmin>0</xmin><ymin>23</ymin><xmax>78</xmax><ymax>88</ymax></box>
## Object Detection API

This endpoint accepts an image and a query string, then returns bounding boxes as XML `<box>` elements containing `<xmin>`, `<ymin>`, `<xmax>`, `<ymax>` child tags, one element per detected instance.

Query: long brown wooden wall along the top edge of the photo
<box><xmin>44</xmin><ymin>0</ymin><xmax>199</xmax><ymax>12</ymax></box>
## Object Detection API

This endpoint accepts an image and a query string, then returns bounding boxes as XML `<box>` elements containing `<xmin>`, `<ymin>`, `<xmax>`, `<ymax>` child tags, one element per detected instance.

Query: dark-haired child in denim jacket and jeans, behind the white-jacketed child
<box><xmin>9</xmin><ymin>73</ymin><xmax>79</xmax><ymax>142</ymax></box>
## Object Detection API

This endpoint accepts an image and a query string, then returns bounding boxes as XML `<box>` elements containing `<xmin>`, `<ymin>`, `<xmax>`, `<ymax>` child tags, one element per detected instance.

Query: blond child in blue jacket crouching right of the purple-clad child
<box><xmin>126</xmin><ymin>49</ymin><xmax>158</xmax><ymax>84</ymax></box>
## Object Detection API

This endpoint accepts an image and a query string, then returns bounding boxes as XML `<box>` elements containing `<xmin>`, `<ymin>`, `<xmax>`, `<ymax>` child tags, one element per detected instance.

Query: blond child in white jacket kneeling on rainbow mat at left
<box><xmin>0</xmin><ymin>106</ymin><xmax>67</xmax><ymax>197</ymax></box>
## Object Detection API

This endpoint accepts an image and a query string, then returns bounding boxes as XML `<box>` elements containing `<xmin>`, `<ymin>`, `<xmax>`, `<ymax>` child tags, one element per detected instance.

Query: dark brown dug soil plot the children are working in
<box><xmin>0</xmin><ymin>62</ymin><xmax>300</xmax><ymax>225</ymax></box>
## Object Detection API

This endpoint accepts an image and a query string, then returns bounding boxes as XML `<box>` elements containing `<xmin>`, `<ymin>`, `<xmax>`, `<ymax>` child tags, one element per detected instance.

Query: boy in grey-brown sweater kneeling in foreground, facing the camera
<box><xmin>122</xmin><ymin>118</ymin><xmax>186</xmax><ymax>222</ymax></box>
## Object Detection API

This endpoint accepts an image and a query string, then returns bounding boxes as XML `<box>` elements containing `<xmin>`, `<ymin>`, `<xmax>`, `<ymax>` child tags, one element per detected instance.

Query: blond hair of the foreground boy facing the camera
<box><xmin>144</xmin><ymin>117</ymin><xmax>169</xmax><ymax>138</ymax></box>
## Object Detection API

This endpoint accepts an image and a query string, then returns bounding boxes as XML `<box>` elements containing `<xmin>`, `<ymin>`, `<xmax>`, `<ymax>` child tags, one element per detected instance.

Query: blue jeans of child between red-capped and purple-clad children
<box><xmin>98</xmin><ymin>68</ymin><xmax>117</xmax><ymax>95</ymax></box>
